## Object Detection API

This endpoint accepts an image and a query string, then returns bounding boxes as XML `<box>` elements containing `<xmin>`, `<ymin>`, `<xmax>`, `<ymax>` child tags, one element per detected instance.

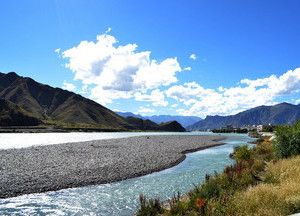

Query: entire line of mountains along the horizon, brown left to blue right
<box><xmin>0</xmin><ymin>72</ymin><xmax>300</xmax><ymax>131</ymax></box>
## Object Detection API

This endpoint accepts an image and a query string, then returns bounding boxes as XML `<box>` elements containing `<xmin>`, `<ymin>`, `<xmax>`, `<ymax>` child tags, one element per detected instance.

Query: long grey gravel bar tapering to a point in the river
<box><xmin>0</xmin><ymin>135</ymin><xmax>224</xmax><ymax>198</ymax></box>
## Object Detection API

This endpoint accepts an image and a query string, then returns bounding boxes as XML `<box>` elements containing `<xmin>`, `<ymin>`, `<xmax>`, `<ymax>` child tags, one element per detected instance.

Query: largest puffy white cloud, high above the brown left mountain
<box><xmin>62</xmin><ymin>34</ymin><xmax>182</xmax><ymax>104</ymax></box>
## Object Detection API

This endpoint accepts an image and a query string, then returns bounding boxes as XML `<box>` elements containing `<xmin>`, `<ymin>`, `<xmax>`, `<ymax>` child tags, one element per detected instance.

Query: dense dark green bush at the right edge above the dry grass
<box><xmin>274</xmin><ymin>121</ymin><xmax>300</xmax><ymax>158</ymax></box>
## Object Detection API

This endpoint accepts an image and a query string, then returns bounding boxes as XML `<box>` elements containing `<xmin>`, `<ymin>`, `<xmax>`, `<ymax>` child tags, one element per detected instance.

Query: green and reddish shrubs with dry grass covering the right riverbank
<box><xmin>137</xmin><ymin>122</ymin><xmax>300</xmax><ymax>216</ymax></box>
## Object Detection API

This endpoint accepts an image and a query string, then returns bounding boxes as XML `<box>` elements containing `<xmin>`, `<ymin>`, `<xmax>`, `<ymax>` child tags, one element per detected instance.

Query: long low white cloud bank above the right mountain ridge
<box><xmin>166</xmin><ymin>68</ymin><xmax>300</xmax><ymax>117</ymax></box>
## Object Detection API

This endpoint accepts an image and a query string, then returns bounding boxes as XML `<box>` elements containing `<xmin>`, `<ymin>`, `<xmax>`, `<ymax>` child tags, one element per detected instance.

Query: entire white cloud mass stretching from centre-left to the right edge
<box><xmin>59</xmin><ymin>32</ymin><xmax>300</xmax><ymax>117</ymax></box>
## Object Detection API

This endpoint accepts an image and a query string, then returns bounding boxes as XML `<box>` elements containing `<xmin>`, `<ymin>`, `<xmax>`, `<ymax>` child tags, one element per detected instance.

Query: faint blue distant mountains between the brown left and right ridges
<box><xmin>117</xmin><ymin>112</ymin><xmax>202</xmax><ymax>127</ymax></box>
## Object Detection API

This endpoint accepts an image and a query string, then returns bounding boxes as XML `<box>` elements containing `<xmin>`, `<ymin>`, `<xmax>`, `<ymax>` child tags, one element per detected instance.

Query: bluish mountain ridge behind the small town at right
<box><xmin>187</xmin><ymin>103</ymin><xmax>300</xmax><ymax>131</ymax></box>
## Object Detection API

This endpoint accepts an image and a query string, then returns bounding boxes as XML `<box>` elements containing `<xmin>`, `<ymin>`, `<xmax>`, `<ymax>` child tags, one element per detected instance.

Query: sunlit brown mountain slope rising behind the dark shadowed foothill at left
<box><xmin>0</xmin><ymin>72</ymin><xmax>129</xmax><ymax>129</ymax></box>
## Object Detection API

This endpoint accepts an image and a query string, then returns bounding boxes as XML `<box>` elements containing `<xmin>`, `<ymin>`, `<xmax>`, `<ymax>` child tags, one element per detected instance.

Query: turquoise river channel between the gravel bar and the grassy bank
<box><xmin>0</xmin><ymin>134</ymin><xmax>252</xmax><ymax>215</ymax></box>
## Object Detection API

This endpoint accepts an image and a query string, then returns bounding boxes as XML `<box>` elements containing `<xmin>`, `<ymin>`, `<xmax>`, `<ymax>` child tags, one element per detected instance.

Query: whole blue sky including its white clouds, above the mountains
<box><xmin>0</xmin><ymin>0</ymin><xmax>300</xmax><ymax>117</ymax></box>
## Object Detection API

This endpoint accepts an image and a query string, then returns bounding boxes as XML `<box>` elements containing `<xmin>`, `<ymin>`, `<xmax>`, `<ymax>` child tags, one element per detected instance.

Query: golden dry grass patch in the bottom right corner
<box><xmin>232</xmin><ymin>156</ymin><xmax>300</xmax><ymax>216</ymax></box>
